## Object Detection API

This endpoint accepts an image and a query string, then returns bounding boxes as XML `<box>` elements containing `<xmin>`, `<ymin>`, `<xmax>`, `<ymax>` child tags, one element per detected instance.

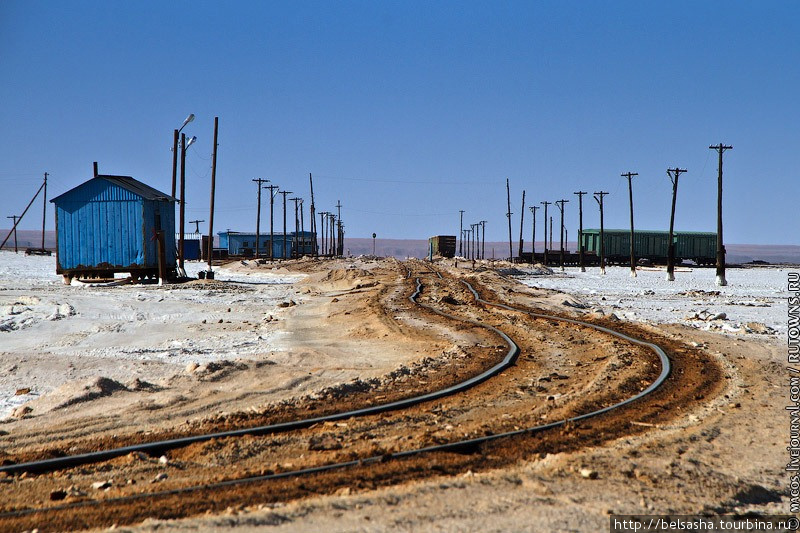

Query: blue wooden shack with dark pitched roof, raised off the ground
<box><xmin>51</xmin><ymin>174</ymin><xmax>177</xmax><ymax>283</ymax></box>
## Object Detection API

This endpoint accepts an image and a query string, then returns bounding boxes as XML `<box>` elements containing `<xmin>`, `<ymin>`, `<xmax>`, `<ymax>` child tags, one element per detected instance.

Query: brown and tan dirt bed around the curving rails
<box><xmin>0</xmin><ymin>261</ymin><xmax>785</xmax><ymax>531</ymax></box>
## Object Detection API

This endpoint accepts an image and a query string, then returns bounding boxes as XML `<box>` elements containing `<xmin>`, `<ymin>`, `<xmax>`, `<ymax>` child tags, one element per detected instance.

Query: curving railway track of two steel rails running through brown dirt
<box><xmin>0</xmin><ymin>263</ymin><xmax>684</xmax><ymax>527</ymax></box>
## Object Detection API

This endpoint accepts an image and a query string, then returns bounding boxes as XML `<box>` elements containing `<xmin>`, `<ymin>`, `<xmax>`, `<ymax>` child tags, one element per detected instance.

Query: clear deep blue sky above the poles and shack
<box><xmin>0</xmin><ymin>0</ymin><xmax>800</xmax><ymax>244</ymax></box>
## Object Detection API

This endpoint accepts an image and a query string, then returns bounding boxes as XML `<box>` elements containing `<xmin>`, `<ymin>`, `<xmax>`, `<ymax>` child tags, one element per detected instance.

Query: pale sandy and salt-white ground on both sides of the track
<box><xmin>0</xmin><ymin>252</ymin><xmax>789</xmax><ymax>532</ymax></box>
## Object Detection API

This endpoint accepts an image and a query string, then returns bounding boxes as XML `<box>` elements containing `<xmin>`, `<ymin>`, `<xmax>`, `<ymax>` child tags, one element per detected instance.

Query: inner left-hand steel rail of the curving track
<box><xmin>0</xmin><ymin>264</ymin><xmax>519</xmax><ymax>475</ymax></box>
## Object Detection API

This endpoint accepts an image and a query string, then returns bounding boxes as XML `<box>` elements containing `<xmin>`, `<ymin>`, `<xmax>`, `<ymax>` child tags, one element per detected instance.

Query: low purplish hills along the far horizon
<box><xmin>0</xmin><ymin>228</ymin><xmax>800</xmax><ymax>265</ymax></box>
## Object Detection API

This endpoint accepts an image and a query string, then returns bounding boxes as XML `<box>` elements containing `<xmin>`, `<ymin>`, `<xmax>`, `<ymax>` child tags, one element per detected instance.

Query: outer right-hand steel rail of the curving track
<box><xmin>0</xmin><ymin>266</ymin><xmax>671</xmax><ymax>518</ymax></box>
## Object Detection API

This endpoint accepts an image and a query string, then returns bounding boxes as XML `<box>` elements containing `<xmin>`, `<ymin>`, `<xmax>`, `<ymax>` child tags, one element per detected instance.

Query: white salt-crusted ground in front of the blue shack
<box><xmin>0</xmin><ymin>251</ymin><xmax>305</xmax><ymax>419</ymax></box>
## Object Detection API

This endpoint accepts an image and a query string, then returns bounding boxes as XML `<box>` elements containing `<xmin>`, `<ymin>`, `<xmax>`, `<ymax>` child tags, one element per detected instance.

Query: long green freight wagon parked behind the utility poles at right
<box><xmin>581</xmin><ymin>229</ymin><xmax>717</xmax><ymax>265</ymax></box>
